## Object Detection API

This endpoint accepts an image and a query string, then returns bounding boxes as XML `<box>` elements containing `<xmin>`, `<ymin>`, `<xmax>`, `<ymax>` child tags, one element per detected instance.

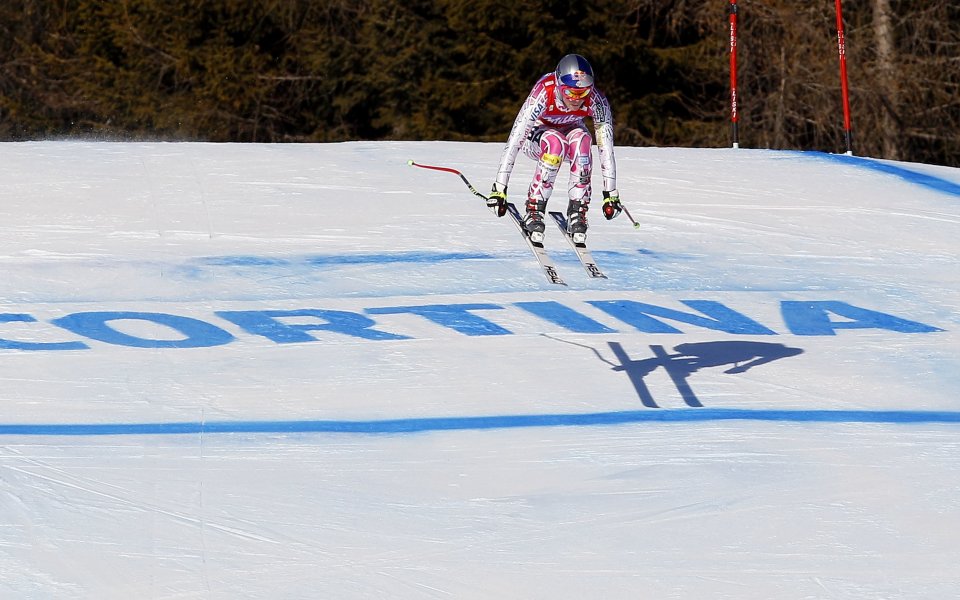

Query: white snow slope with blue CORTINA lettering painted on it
<box><xmin>0</xmin><ymin>142</ymin><xmax>960</xmax><ymax>599</ymax></box>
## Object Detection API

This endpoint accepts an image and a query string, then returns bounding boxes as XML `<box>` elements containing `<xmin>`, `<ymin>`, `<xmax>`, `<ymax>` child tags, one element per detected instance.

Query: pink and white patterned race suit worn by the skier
<box><xmin>497</xmin><ymin>73</ymin><xmax>617</xmax><ymax>210</ymax></box>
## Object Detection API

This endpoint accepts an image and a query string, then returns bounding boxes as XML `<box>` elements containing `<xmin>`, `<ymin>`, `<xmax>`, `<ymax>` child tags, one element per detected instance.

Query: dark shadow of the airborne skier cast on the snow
<box><xmin>604</xmin><ymin>342</ymin><xmax>803</xmax><ymax>408</ymax></box>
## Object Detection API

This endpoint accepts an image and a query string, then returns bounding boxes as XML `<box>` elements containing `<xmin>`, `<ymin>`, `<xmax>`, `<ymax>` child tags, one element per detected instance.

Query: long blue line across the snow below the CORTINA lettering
<box><xmin>0</xmin><ymin>408</ymin><xmax>960</xmax><ymax>436</ymax></box>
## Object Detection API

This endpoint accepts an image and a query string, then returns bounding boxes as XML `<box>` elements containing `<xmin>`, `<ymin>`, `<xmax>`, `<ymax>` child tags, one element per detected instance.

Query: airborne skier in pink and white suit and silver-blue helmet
<box><xmin>487</xmin><ymin>54</ymin><xmax>621</xmax><ymax>243</ymax></box>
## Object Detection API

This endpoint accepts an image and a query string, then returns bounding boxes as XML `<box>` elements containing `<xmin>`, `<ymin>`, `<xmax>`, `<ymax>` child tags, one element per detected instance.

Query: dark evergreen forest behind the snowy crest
<box><xmin>0</xmin><ymin>0</ymin><xmax>960</xmax><ymax>166</ymax></box>
